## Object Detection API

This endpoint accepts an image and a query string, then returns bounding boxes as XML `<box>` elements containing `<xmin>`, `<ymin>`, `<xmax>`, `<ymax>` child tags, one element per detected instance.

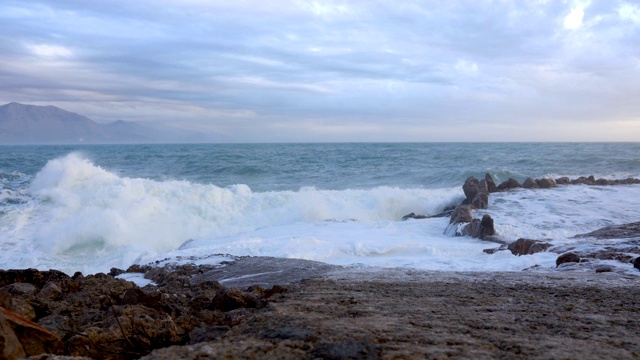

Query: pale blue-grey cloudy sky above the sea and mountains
<box><xmin>0</xmin><ymin>0</ymin><xmax>640</xmax><ymax>142</ymax></box>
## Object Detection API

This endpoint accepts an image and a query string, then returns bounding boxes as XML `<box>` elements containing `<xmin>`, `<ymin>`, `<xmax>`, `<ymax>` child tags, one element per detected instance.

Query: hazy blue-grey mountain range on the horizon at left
<box><xmin>0</xmin><ymin>102</ymin><xmax>215</xmax><ymax>145</ymax></box>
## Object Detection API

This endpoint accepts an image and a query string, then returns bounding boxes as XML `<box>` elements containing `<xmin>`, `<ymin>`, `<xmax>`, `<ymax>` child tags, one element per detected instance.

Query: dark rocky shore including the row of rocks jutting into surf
<box><xmin>0</xmin><ymin>174</ymin><xmax>640</xmax><ymax>359</ymax></box>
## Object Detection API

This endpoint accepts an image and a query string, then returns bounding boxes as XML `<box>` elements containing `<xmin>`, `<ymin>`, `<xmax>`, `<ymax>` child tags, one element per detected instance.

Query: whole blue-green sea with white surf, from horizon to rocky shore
<box><xmin>0</xmin><ymin>143</ymin><xmax>640</xmax><ymax>274</ymax></box>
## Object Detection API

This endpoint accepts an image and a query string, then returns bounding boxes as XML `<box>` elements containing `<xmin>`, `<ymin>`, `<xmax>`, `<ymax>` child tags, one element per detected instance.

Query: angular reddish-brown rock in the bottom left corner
<box><xmin>0</xmin><ymin>307</ymin><xmax>63</xmax><ymax>359</ymax></box>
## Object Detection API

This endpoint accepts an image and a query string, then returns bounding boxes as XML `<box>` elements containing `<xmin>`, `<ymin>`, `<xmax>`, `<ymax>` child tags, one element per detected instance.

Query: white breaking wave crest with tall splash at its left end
<box><xmin>23</xmin><ymin>153</ymin><xmax>462</xmax><ymax>253</ymax></box>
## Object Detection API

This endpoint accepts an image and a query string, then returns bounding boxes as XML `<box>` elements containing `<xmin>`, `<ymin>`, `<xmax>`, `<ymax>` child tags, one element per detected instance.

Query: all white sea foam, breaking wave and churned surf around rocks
<box><xmin>0</xmin><ymin>153</ymin><xmax>640</xmax><ymax>273</ymax></box>
